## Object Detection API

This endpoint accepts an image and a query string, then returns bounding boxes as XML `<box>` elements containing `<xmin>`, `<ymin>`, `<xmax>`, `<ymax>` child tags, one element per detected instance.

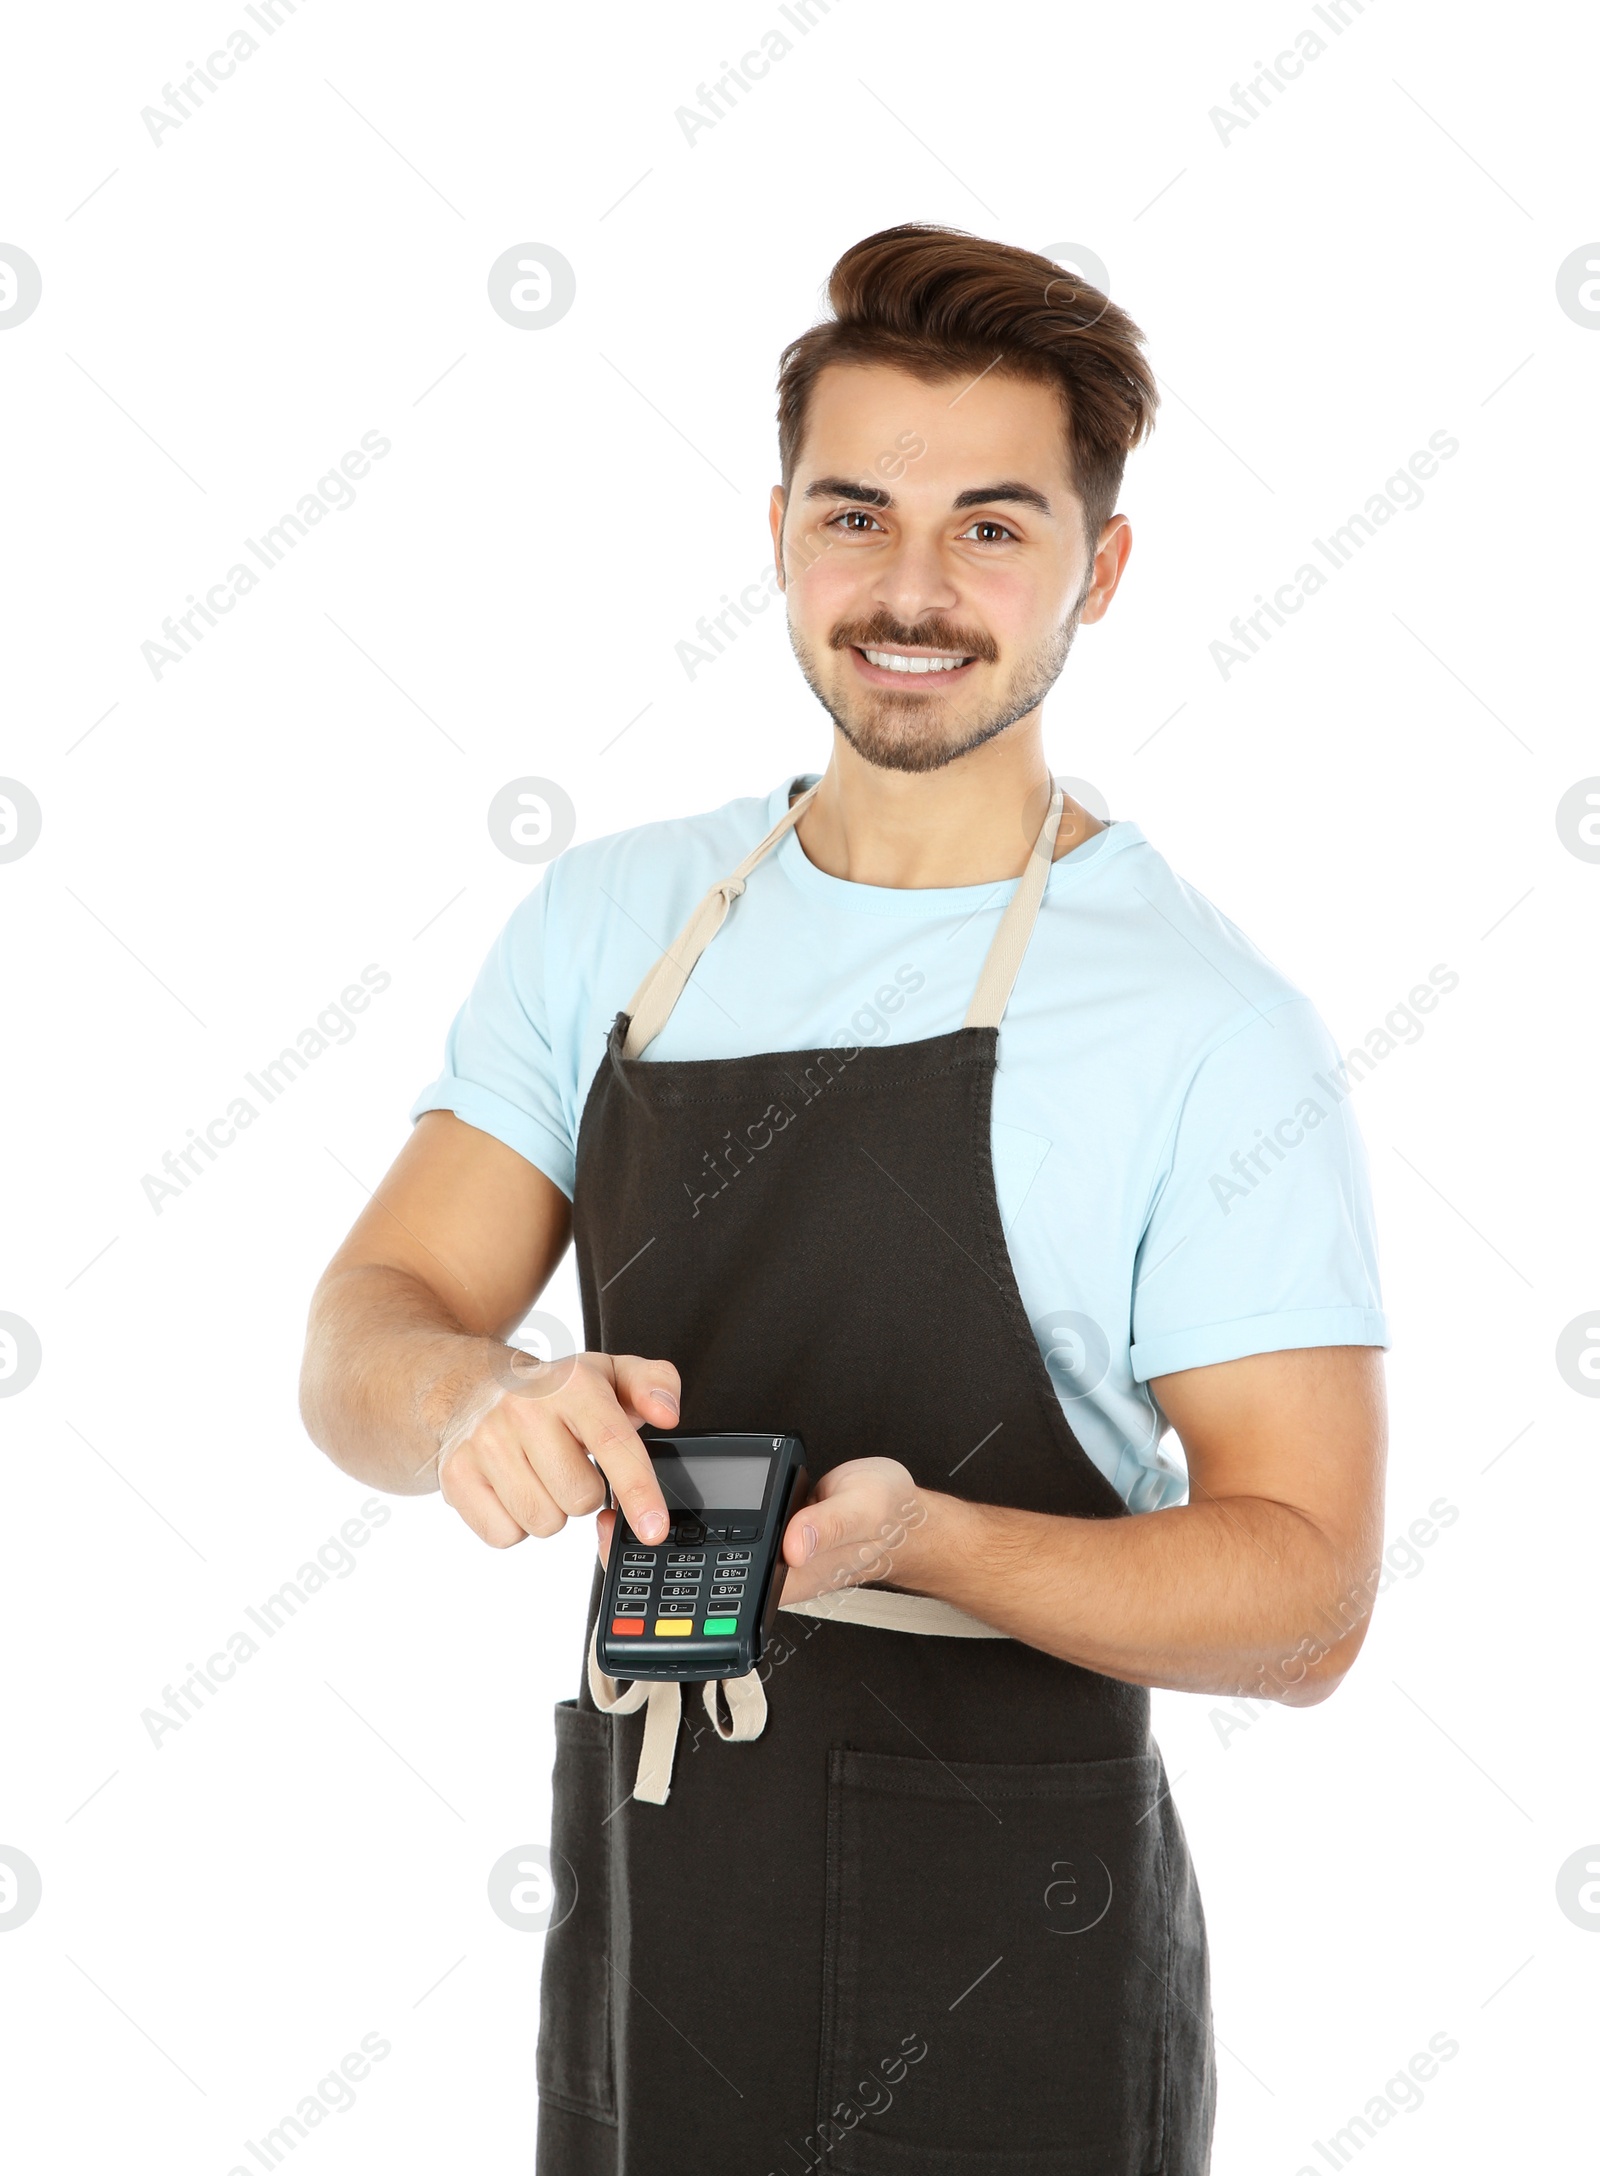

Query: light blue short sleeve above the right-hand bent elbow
<box><xmin>1132</xmin><ymin>997</ymin><xmax>1389</xmax><ymax>1382</ymax></box>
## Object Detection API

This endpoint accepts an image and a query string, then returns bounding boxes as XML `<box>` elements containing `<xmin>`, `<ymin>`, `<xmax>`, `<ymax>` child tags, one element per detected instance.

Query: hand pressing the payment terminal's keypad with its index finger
<box><xmin>438</xmin><ymin>1353</ymin><xmax>681</xmax><ymax>1549</ymax></box>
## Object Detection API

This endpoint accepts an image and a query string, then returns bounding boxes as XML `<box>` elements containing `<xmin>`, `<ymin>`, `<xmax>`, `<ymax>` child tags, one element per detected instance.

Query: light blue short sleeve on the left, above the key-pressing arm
<box><xmin>411</xmin><ymin>870</ymin><xmax>577</xmax><ymax>1199</ymax></box>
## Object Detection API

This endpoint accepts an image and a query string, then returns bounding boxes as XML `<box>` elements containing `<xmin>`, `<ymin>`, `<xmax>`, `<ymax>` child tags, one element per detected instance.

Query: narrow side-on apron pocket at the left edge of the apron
<box><xmin>536</xmin><ymin>1699</ymin><xmax>616</xmax><ymax>2124</ymax></box>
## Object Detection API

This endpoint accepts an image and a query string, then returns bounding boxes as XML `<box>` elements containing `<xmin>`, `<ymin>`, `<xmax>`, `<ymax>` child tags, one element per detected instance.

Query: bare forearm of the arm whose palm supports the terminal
<box><xmin>888</xmin><ymin>1491</ymin><xmax>1376</xmax><ymax>1706</ymax></box>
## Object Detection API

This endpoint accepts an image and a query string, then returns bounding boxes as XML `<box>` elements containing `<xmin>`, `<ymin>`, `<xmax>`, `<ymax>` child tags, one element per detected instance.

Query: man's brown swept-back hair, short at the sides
<box><xmin>777</xmin><ymin>224</ymin><xmax>1160</xmax><ymax>551</ymax></box>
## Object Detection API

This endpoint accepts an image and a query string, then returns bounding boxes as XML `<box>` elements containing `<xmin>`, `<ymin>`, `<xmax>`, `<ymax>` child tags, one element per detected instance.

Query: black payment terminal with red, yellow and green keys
<box><xmin>596</xmin><ymin>1427</ymin><xmax>805</xmax><ymax>1680</ymax></box>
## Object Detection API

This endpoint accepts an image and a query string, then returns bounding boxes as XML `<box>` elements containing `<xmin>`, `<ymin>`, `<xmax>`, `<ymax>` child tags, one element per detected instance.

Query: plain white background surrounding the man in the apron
<box><xmin>0</xmin><ymin>0</ymin><xmax>1600</xmax><ymax>2176</ymax></box>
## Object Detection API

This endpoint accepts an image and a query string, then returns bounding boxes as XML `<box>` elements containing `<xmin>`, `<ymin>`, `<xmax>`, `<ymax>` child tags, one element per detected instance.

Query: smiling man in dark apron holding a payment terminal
<box><xmin>303</xmin><ymin>226</ymin><xmax>1387</xmax><ymax>2176</ymax></box>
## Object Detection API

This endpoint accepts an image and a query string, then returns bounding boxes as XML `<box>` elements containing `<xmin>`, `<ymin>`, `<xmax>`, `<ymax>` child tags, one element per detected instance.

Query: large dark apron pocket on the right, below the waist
<box><xmin>814</xmin><ymin>1747</ymin><xmax>1171</xmax><ymax>2176</ymax></box>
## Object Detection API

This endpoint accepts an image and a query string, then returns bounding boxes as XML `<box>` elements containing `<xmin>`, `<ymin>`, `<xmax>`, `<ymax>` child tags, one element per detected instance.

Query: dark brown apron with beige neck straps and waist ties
<box><xmin>538</xmin><ymin>794</ymin><xmax>1215</xmax><ymax>2176</ymax></box>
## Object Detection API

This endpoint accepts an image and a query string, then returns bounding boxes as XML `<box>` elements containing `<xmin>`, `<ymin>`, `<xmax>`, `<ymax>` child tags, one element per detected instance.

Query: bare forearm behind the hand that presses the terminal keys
<box><xmin>300</xmin><ymin>1264</ymin><xmax>507</xmax><ymax>1495</ymax></box>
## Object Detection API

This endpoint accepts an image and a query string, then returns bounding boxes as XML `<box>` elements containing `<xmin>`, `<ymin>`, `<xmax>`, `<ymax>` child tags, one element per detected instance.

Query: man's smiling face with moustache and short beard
<box><xmin>773</xmin><ymin>363</ymin><xmax>1130</xmax><ymax>770</ymax></box>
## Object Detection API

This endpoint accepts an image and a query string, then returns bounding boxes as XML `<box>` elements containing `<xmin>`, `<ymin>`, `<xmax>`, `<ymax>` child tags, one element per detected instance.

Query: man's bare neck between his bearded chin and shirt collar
<box><xmin>795</xmin><ymin>714</ymin><xmax>1106</xmax><ymax>892</ymax></box>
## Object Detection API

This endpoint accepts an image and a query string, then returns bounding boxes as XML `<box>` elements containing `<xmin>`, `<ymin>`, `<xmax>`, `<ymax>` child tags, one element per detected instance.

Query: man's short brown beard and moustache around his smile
<box><xmin>788</xmin><ymin>581</ymin><xmax>1088</xmax><ymax>772</ymax></box>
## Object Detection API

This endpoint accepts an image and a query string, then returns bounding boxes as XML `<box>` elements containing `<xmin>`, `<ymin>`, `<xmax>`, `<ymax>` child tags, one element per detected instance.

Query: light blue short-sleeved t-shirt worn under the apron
<box><xmin>411</xmin><ymin>777</ymin><xmax>1389</xmax><ymax>1510</ymax></box>
